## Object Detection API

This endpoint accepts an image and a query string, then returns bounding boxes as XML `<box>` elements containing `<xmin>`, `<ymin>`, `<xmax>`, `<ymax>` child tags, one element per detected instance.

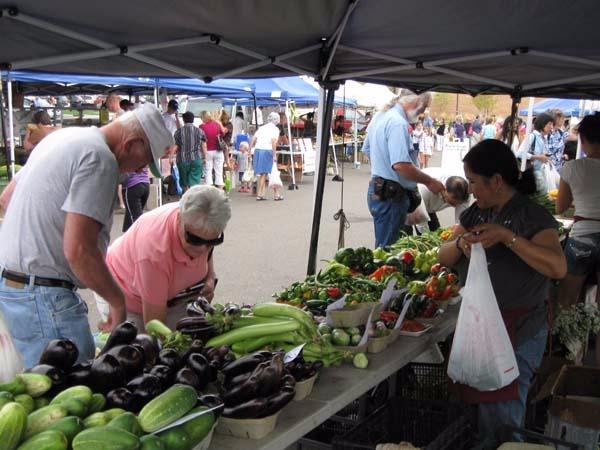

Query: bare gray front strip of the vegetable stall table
<box><xmin>210</xmin><ymin>306</ymin><xmax>459</xmax><ymax>450</ymax></box>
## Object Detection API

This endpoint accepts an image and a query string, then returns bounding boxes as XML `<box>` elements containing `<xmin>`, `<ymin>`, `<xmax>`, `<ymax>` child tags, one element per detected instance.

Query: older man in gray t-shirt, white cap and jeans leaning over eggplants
<box><xmin>0</xmin><ymin>105</ymin><xmax>174</xmax><ymax>367</ymax></box>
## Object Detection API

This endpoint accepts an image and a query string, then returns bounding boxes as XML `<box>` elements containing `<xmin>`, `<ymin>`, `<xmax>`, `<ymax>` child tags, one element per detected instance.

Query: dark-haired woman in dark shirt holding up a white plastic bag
<box><xmin>439</xmin><ymin>139</ymin><xmax>566</xmax><ymax>448</ymax></box>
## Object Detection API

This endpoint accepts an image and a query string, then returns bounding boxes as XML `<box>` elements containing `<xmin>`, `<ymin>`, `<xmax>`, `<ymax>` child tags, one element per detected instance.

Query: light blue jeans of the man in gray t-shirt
<box><xmin>0</xmin><ymin>278</ymin><xmax>94</xmax><ymax>368</ymax></box>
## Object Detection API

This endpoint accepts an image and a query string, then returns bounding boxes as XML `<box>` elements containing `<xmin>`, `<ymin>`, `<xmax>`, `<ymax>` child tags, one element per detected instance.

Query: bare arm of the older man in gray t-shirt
<box><xmin>63</xmin><ymin>212</ymin><xmax>126</xmax><ymax>330</ymax></box>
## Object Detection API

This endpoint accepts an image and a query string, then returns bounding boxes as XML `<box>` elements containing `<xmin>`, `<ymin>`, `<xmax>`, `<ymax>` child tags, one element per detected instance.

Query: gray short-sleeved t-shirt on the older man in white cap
<box><xmin>0</xmin><ymin>128</ymin><xmax>119</xmax><ymax>287</ymax></box>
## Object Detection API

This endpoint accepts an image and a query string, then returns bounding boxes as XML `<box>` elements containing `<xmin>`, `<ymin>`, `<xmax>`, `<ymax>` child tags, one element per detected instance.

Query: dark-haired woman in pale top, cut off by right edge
<box><xmin>556</xmin><ymin>114</ymin><xmax>600</xmax><ymax>365</ymax></box>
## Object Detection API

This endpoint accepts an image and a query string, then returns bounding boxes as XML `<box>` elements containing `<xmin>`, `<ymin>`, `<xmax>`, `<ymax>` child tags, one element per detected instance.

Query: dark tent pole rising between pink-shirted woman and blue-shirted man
<box><xmin>307</xmin><ymin>83</ymin><xmax>339</xmax><ymax>275</ymax></box>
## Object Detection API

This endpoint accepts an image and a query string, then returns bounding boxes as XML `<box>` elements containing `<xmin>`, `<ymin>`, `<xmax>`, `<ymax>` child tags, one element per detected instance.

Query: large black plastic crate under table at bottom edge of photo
<box><xmin>333</xmin><ymin>397</ymin><xmax>475</xmax><ymax>450</ymax></box>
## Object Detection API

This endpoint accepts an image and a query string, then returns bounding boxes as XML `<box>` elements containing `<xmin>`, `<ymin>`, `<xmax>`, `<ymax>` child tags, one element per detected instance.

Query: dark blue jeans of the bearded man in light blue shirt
<box><xmin>367</xmin><ymin>181</ymin><xmax>409</xmax><ymax>247</ymax></box>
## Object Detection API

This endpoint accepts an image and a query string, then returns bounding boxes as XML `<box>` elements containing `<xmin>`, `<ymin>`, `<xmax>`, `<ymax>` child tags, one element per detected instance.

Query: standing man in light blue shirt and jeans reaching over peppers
<box><xmin>363</xmin><ymin>91</ymin><xmax>444</xmax><ymax>247</ymax></box>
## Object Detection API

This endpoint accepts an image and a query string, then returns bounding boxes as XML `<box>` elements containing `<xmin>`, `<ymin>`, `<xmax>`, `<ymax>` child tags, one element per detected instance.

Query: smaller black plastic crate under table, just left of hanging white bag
<box><xmin>396</xmin><ymin>363</ymin><xmax>452</xmax><ymax>400</ymax></box>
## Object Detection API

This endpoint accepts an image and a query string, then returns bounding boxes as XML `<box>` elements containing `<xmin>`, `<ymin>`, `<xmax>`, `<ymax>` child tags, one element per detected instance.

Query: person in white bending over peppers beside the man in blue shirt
<box><xmin>405</xmin><ymin>168</ymin><xmax>469</xmax><ymax>234</ymax></box>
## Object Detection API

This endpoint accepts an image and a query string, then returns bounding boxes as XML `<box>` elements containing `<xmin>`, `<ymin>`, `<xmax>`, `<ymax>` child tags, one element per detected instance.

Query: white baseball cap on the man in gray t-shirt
<box><xmin>133</xmin><ymin>103</ymin><xmax>175</xmax><ymax>178</ymax></box>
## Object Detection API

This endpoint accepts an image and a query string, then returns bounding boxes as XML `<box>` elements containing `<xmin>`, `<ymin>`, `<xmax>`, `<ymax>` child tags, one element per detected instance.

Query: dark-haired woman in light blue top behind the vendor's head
<box><xmin>517</xmin><ymin>113</ymin><xmax>554</xmax><ymax>194</ymax></box>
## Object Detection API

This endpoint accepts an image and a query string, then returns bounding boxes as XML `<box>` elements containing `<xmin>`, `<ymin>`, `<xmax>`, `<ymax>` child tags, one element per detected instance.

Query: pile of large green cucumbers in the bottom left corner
<box><xmin>0</xmin><ymin>374</ymin><xmax>219</xmax><ymax>450</ymax></box>
